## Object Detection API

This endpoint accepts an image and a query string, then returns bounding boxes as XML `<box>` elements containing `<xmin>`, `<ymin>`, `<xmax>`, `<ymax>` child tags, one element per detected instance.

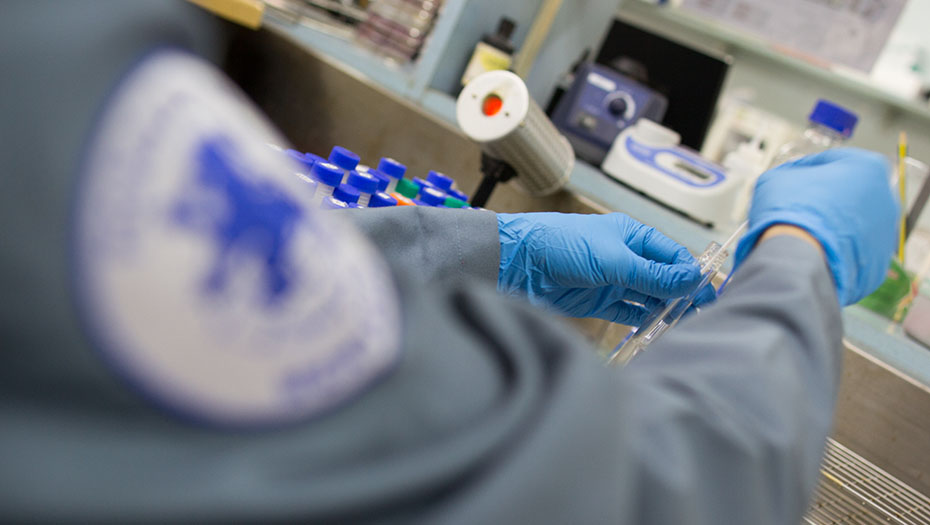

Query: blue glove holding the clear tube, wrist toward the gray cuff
<box><xmin>497</xmin><ymin>213</ymin><xmax>714</xmax><ymax>326</ymax></box>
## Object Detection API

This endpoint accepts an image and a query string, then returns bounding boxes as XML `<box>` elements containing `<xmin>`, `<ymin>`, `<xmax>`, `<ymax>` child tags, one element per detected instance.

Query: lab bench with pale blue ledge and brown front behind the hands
<box><xmin>219</xmin><ymin>17</ymin><xmax>930</xmax><ymax>500</ymax></box>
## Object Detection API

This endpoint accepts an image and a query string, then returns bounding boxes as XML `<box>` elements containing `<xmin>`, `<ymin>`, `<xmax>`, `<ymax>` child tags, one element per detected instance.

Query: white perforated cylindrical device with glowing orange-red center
<box><xmin>456</xmin><ymin>71</ymin><xmax>575</xmax><ymax>206</ymax></box>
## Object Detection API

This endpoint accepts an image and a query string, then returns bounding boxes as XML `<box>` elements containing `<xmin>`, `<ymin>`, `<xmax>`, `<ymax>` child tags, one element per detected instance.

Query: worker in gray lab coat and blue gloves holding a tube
<box><xmin>0</xmin><ymin>1</ymin><xmax>896</xmax><ymax>525</ymax></box>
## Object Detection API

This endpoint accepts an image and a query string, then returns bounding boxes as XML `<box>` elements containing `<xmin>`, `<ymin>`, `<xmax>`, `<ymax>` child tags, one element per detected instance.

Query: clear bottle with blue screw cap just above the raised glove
<box><xmin>772</xmin><ymin>99</ymin><xmax>859</xmax><ymax>167</ymax></box>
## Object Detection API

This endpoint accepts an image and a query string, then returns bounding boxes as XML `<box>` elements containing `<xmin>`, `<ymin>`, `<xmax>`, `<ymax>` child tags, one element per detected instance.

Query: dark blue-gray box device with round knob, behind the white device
<box><xmin>552</xmin><ymin>63</ymin><xmax>668</xmax><ymax>166</ymax></box>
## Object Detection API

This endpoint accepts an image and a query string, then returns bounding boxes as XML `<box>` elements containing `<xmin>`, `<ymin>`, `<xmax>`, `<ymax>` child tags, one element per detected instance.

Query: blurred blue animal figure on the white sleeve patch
<box><xmin>172</xmin><ymin>138</ymin><xmax>302</xmax><ymax>304</ymax></box>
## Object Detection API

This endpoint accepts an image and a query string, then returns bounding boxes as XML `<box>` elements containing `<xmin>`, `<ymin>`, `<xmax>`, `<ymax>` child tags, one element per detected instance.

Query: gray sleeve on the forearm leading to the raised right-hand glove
<box><xmin>622</xmin><ymin>237</ymin><xmax>842</xmax><ymax>524</ymax></box>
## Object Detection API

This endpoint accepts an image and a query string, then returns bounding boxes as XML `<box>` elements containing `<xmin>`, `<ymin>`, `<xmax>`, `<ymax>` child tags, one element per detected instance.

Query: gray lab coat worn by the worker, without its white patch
<box><xmin>0</xmin><ymin>2</ymin><xmax>841</xmax><ymax>524</ymax></box>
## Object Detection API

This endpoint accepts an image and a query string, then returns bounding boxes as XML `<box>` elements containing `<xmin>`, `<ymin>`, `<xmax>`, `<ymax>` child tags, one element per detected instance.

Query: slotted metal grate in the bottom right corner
<box><xmin>804</xmin><ymin>439</ymin><xmax>930</xmax><ymax>525</ymax></box>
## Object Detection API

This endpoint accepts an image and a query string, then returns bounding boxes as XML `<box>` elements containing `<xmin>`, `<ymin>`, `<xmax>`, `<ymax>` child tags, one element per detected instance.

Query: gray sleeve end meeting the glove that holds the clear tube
<box><xmin>336</xmin><ymin>206</ymin><xmax>500</xmax><ymax>285</ymax></box>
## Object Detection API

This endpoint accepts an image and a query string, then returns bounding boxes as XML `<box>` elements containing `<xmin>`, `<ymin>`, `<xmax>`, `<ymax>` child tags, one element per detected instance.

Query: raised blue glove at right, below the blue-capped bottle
<box><xmin>735</xmin><ymin>148</ymin><xmax>898</xmax><ymax>306</ymax></box>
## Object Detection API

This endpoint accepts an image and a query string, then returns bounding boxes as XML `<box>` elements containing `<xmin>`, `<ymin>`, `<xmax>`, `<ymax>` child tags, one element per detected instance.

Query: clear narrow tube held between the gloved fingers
<box><xmin>607</xmin><ymin>222</ymin><xmax>748</xmax><ymax>366</ymax></box>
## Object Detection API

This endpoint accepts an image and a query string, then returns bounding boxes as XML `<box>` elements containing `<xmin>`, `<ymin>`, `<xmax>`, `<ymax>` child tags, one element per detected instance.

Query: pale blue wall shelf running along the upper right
<box><xmin>618</xmin><ymin>2</ymin><xmax>930</xmax><ymax>122</ymax></box>
